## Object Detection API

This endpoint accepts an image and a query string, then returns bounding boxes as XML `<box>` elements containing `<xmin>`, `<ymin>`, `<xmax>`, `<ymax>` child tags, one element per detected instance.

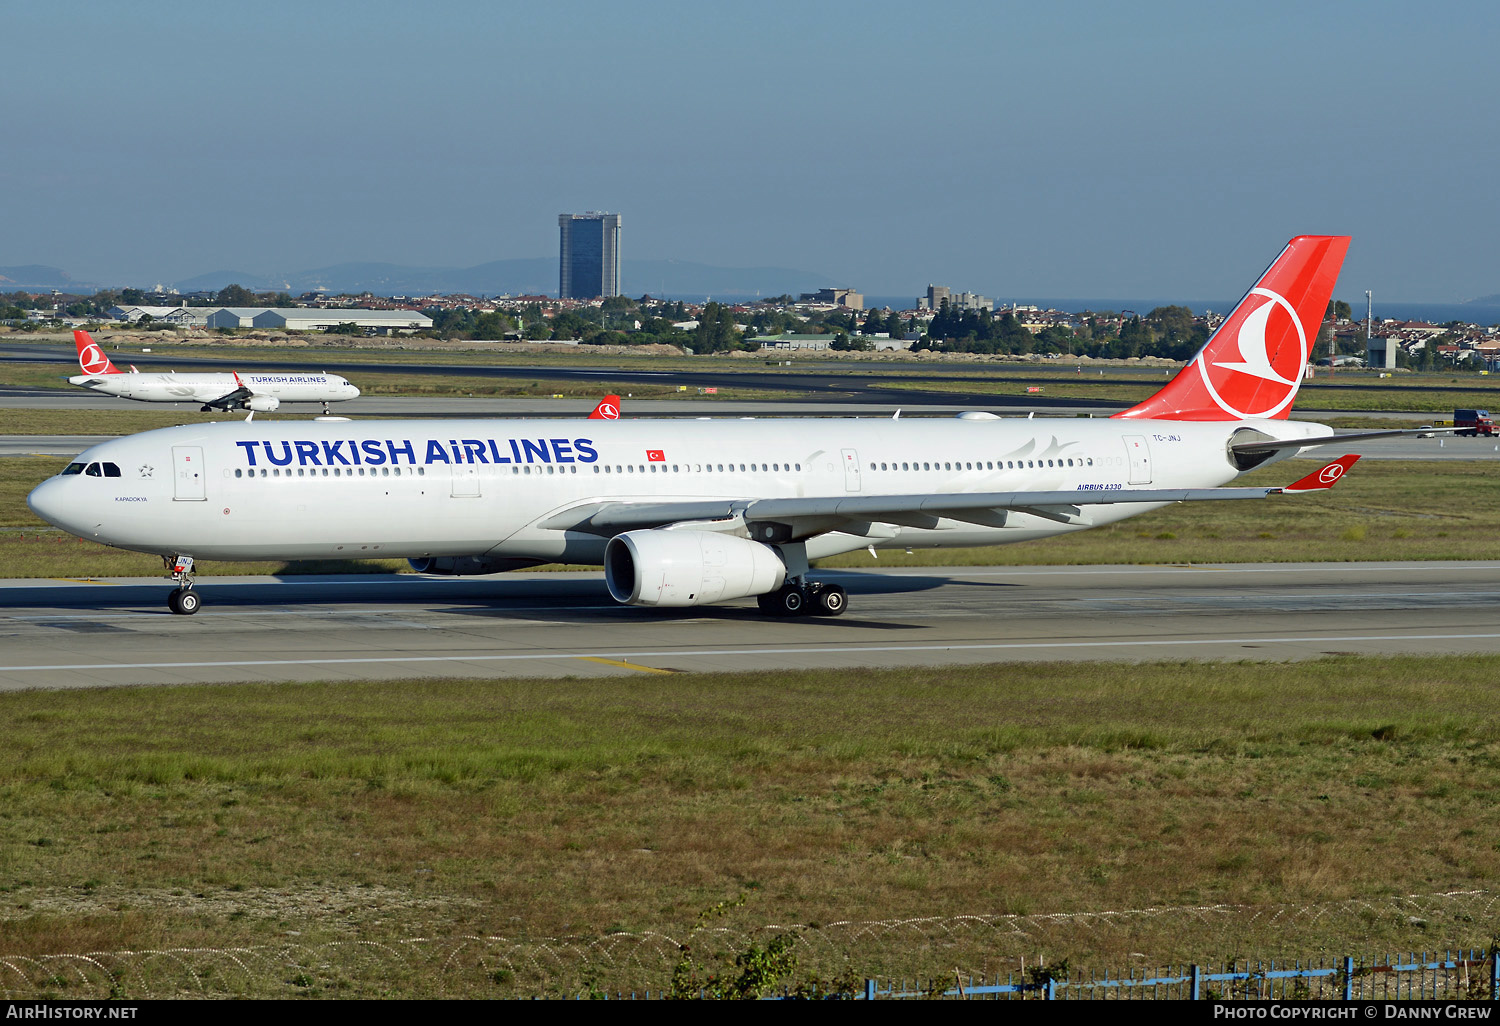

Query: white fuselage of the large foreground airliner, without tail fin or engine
<box><xmin>29</xmin><ymin>419</ymin><xmax>1328</xmax><ymax>563</ymax></box>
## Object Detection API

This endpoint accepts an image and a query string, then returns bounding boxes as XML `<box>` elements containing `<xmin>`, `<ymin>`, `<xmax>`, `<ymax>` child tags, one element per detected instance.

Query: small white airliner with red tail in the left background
<box><xmin>68</xmin><ymin>332</ymin><xmax>360</xmax><ymax>414</ymax></box>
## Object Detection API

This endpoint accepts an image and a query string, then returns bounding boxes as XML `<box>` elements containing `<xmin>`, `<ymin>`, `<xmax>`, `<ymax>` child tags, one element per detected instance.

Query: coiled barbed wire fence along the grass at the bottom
<box><xmin>0</xmin><ymin>891</ymin><xmax>1500</xmax><ymax>1001</ymax></box>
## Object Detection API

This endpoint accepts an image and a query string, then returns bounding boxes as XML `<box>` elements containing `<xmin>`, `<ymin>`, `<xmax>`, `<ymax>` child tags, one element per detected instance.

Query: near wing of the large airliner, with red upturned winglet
<box><xmin>539</xmin><ymin>456</ymin><xmax>1359</xmax><ymax>545</ymax></box>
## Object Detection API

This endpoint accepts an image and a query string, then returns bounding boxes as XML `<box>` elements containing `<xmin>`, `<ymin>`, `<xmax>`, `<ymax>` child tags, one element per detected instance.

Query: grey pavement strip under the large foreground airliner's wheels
<box><xmin>0</xmin><ymin>555</ymin><xmax>1500</xmax><ymax>690</ymax></box>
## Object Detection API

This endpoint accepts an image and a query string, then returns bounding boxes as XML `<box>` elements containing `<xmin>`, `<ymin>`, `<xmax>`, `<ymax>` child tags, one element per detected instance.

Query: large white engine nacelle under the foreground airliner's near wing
<box><xmin>605</xmin><ymin>531</ymin><xmax>786</xmax><ymax>606</ymax></box>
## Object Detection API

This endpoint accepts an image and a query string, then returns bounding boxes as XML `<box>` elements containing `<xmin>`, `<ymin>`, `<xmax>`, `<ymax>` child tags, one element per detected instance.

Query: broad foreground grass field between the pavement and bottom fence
<box><xmin>0</xmin><ymin>656</ymin><xmax>1500</xmax><ymax>993</ymax></box>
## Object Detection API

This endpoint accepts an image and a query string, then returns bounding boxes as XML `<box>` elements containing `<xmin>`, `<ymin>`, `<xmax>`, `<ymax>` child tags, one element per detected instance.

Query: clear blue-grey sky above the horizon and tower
<box><xmin>0</xmin><ymin>0</ymin><xmax>1500</xmax><ymax>305</ymax></box>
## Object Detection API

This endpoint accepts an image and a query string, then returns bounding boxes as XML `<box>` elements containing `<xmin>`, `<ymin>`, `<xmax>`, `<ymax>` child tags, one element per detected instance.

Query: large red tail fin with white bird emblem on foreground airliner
<box><xmin>1115</xmin><ymin>236</ymin><xmax>1349</xmax><ymax>420</ymax></box>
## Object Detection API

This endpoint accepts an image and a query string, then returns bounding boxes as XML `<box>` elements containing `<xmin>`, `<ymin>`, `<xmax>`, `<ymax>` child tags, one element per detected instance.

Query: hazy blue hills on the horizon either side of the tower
<box><xmin>173</xmin><ymin>257</ymin><xmax>843</xmax><ymax>296</ymax></box>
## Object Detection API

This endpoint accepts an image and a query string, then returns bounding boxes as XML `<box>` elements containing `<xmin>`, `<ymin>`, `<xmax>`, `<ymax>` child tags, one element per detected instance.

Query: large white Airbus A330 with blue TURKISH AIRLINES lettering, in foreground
<box><xmin>27</xmin><ymin>236</ymin><xmax>1416</xmax><ymax>615</ymax></box>
